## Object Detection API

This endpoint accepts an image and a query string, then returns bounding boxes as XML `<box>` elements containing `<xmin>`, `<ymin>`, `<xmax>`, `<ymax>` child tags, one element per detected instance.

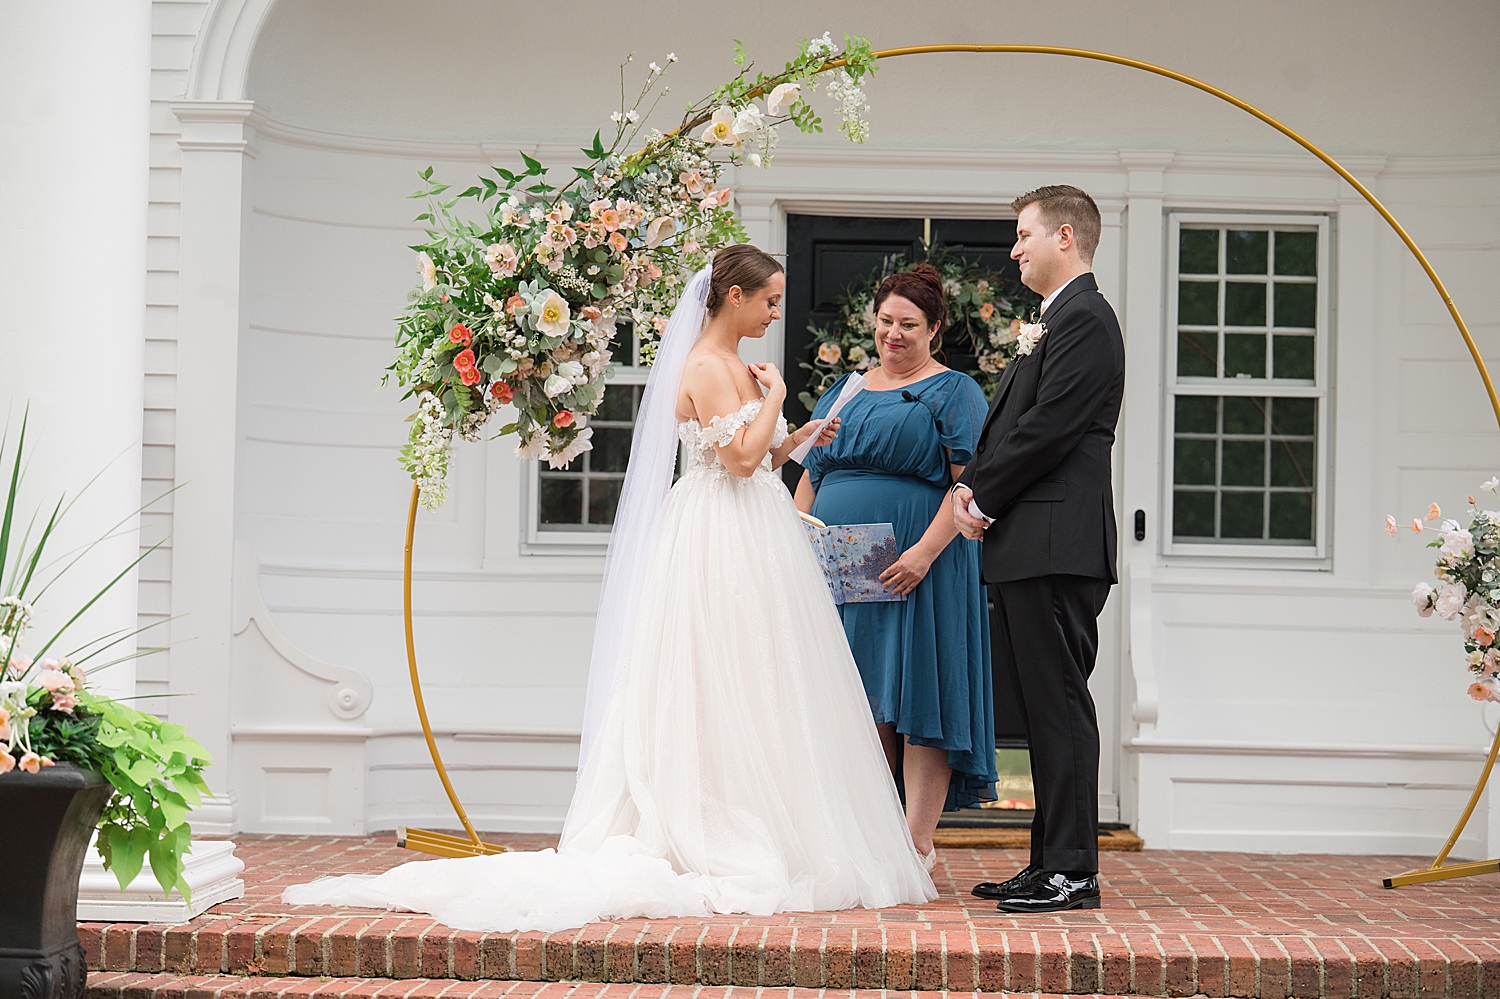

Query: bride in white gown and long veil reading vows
<box><xmin>282</xmin><ymin>245</ymin><xmax>938</xmax><ymax>932</ymax></box>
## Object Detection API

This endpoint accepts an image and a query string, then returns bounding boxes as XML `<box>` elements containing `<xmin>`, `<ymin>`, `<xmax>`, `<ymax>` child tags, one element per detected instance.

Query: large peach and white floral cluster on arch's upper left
<box><xmin>387</xmin><ymin>33</ymin><xmax>875</xmax><ymax>509</ymax></box>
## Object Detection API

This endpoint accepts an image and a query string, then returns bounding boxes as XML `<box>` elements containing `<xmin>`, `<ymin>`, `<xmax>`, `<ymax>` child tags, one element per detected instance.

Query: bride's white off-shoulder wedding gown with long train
<box><xmin>282</xmin><ymin>401</ymin><xmax>938</xmax><ymax>932</ymax></box>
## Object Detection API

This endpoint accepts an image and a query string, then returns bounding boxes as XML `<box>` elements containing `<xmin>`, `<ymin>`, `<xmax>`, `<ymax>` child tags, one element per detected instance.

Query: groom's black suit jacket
<box><xmin>959</xmin><ymin>275</ymin><xmax>1125</xmax><ymax>584</ymax></box>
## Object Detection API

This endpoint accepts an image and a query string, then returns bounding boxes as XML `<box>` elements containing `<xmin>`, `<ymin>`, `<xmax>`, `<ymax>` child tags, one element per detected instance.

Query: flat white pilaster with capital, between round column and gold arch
<box><xmin>168</xmin><ymin>101</ymin><xmax>255</xmax><ymax>831</ymax></box>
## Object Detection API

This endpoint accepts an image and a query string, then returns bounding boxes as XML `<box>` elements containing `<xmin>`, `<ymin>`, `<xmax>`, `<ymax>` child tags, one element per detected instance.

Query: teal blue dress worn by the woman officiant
<box><xmin>803</xmin><ymin>371</ymin><xmax>998</xmax><ymax>809</ymax></box>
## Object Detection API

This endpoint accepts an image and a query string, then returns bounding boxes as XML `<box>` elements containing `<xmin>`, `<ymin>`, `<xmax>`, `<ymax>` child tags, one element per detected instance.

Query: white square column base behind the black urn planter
<box><xmin>78</xmin><ymin>840</ymin><xmax>245</xmax><ymax>924</ymax></box>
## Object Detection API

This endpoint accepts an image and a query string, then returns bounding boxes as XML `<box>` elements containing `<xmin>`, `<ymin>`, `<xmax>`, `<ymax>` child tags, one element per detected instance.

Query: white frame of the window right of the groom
<box><xmin>1158</xmin><ymin>212</ymin><xmax>1335</xmax><ymax>569</ymax></box>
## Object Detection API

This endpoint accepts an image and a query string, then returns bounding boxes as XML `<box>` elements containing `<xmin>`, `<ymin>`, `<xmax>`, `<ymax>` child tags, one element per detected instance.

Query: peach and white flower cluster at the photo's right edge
<box><xmin>1386</xmin><ymin>479</ymin><xmax>1500</xmax><ymax>701</ymax></box>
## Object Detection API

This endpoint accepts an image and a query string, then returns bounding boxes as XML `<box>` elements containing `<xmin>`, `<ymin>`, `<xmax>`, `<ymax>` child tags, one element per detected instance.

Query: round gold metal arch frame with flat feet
<box><xmin>396</xmin><ymin>45</ymin><xmax>1500</xmax><ymax>888</ymax></box>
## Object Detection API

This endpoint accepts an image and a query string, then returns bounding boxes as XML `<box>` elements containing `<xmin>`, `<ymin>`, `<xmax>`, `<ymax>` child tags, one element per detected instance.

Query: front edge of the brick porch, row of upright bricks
<box><xmin>80</xmin><ymin>914</ymin><xmax>1500</xmax><ymax>999</ymax></box>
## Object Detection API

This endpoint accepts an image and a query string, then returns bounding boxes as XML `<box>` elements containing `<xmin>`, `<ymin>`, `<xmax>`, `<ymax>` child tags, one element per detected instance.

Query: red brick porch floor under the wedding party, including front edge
<box><xmin>80</xmin><ymin>836</ymin><xmax>1500</xmax><ymax>999</ymax></box>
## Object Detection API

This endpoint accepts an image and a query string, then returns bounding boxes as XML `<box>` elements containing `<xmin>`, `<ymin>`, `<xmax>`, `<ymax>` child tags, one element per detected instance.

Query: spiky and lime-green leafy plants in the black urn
<box><xmin>0</xmin><ymin>419</ymin><xmax>210</xmax><ymax>899</ymax></box>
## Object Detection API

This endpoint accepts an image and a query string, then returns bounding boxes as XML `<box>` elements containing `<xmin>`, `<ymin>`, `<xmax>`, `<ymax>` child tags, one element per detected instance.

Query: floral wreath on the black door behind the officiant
<box><xmin>797</xmin><ymin>251</ymin><xmax>1041</xmax><ymax>413</ymax></box>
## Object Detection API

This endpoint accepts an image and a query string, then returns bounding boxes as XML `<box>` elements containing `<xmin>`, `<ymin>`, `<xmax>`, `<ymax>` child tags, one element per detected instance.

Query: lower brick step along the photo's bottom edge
<box><xmin>84</xmin><ymin>972</ymin><xmax>1152</xmax><ymax>999</ymax></box>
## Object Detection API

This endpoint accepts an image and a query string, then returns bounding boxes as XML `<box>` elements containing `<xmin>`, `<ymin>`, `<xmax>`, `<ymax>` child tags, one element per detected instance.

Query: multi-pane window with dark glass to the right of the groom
<box><xmin>1167</xmin><ymin>215</ymin><xmax>1328</xmax><ymax>555</ymax></box>
